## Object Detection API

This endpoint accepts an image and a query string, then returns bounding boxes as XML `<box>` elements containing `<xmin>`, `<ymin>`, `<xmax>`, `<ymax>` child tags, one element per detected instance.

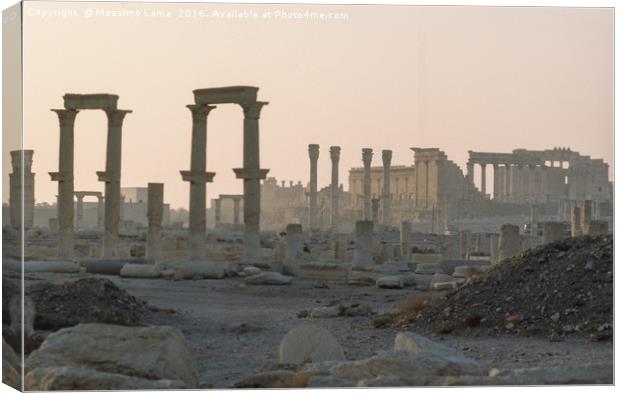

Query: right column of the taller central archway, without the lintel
<box><xmin>234</xmin><ymin>101</ymin><xmax>269</xmax><ymax>263</ymax></box>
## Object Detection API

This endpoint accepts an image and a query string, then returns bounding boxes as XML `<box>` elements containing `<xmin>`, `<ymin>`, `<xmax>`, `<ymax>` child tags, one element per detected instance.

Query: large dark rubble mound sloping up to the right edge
<box><xmin>392</xmin><ymin>235</ymin><xmax>613</xmax><ymax>340</ymax></box>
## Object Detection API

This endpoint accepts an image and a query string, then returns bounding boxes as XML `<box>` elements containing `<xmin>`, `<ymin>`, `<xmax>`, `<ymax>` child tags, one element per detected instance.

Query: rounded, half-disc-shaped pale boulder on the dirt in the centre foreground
<box><xmin>278</xmin><ymin>325</ymin><xmax>345</xmax><ymax>364</ymax></box>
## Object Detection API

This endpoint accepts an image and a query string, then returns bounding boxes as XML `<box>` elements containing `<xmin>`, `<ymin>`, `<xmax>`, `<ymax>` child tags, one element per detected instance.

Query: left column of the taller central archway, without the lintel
<box><xmin>181</xmin><ymin>105</ymin><xmax>215</xmax><ymax>261</ymax></box>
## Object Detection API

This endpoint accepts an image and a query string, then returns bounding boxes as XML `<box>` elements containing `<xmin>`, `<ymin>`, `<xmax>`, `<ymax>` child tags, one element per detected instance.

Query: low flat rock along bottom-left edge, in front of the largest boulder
<box><xmin>25</xmin><ymin>367</ymin><xmax>187</xmax><ymax>391</ymax></box>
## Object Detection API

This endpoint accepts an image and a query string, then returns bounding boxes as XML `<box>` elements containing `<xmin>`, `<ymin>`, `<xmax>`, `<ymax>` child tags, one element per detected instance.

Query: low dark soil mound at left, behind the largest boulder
<box><xmin>26</xmin><ymin>278</ymin><xmax>148</xmax><ymax>330</ymax></box>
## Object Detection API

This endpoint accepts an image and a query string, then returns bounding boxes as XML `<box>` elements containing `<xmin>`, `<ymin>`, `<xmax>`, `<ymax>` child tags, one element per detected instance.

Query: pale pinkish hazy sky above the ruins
<box><xmin>3</xmin><ymin>2</ymin><xmax>613</xmax><ymax>207</ymax></box>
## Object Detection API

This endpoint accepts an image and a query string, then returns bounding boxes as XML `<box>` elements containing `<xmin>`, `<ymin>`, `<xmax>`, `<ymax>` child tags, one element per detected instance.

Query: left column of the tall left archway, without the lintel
<box><xmin>50</xmin><ymin>109</ymin><xmax>78</xmax><ymax>258</ymax></box>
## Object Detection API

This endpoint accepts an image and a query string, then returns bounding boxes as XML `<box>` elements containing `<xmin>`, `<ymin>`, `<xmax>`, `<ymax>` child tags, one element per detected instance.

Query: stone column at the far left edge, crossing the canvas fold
<box><xmin>9</xmin><ymin>150</ymin><xmax>34</xmax><ymax>228</ymax></box>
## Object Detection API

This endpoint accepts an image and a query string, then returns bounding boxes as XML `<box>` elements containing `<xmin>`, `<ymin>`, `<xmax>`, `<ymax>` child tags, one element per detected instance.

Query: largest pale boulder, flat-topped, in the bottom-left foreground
<box><xmin>25</xmin><ymin>323</ymin><xmax>198</xmax><ymax>389</ymax></box>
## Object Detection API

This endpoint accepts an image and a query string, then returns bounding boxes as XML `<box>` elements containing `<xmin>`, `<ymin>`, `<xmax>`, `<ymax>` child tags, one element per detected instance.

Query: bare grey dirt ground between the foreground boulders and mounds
<box><xmin>87</xmin><ymin>276</ymin><xmax>613</xmax><ymax>388</ymax></box>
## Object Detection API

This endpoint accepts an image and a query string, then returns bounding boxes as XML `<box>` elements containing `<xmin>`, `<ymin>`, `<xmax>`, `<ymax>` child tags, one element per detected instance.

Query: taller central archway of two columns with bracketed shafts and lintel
<box><xmin>181</xmin><ymin>86</ymin><xmax>269</xmax><ymax>263</ymax></box>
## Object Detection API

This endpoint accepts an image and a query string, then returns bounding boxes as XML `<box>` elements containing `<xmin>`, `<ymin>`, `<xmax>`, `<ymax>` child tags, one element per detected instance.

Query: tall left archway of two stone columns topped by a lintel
<box><xmin>50</xmin><ymin>94</ymin><xmax>132</xmax><ymax>258</ymax></box>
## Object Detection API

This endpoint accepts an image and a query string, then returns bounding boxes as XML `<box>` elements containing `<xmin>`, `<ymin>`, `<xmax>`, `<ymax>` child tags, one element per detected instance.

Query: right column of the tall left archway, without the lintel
<box><xmin>97</xmin><ymin>109</ymin><xmax>131</xmax><ymax>258</ymax></box>
